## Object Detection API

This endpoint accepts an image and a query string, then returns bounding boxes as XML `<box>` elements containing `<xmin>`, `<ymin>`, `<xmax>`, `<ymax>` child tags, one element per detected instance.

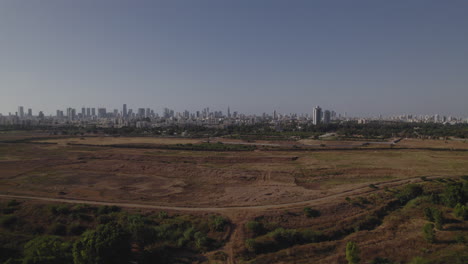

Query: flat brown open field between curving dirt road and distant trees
<box><xmin>0</xmin><ymin>137</ymin><xmax>468</xmax><ymax>206</ymax></box>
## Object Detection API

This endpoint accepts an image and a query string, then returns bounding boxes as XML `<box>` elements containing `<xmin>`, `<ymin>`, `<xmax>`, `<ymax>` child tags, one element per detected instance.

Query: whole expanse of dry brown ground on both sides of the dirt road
<box><xmin>0</xmin><ymin>135</ymin><xmax>468</xmax><ymax>263</ymax></box>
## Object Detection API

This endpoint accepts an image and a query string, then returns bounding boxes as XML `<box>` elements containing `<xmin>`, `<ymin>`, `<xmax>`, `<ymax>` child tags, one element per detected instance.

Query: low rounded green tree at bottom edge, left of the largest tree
<box><xmin>23</xmin><ymin>236</ymin><xmax>72</xmax><ymax>264</ymax></box>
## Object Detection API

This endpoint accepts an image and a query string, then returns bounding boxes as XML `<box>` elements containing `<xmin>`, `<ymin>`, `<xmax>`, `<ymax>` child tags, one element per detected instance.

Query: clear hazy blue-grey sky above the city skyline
<box><xmin>0</xmin><ymin>0</ymin><xmax>468</xmax><ymax>116</ymax></box>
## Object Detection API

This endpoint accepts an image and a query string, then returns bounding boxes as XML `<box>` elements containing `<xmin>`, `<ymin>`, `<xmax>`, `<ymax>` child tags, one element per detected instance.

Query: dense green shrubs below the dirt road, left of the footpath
<box><xmin>0</xmin><ymin>200</ymin><xmax>230</xmax><ymax>264</ymax></box>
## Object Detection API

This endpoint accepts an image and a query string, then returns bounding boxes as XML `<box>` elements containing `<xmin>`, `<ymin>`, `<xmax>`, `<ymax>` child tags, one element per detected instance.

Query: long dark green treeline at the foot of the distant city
<box><xmin>0</xmin><ymin>121</ymin><xmax>468</xmax><ymax>140</ymax></box>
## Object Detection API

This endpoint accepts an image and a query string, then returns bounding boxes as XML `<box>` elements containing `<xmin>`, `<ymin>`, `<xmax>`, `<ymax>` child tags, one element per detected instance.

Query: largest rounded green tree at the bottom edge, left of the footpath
<box><xmin>73</xmin><ymin>223</ymin><xmax>131</xmax><ymax>264</ymax></box>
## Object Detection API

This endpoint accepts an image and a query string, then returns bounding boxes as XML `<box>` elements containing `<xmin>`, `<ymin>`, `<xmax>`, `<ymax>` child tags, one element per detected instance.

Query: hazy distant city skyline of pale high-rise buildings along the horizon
<box><xmin>0</xmin><ymin>104</ymin><xmax>468</xmax><ymax>128</ymax></box>
